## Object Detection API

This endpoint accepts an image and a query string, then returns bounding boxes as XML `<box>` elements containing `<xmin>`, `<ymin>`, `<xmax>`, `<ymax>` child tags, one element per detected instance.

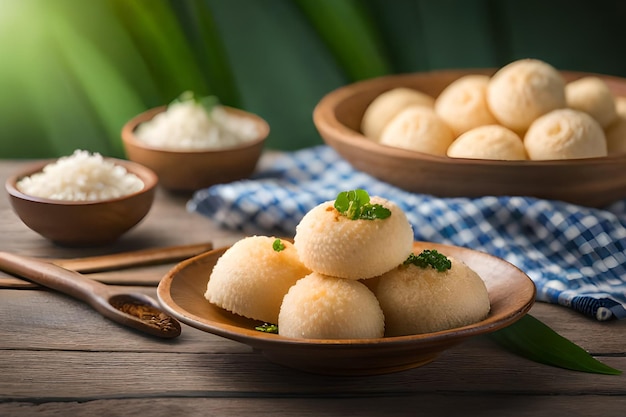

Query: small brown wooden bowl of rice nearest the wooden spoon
<box><xmin>5</xmin><ymin>158</ymin><xmax>158</xmax><ymax>246</ymax></box>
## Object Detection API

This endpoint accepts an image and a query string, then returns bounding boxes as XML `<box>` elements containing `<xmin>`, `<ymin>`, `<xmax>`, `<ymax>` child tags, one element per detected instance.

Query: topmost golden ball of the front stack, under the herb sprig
<box><xmin>294</xmin><ymin>196</ymin><xmax>413</xmax><ymax>280</ymax></box>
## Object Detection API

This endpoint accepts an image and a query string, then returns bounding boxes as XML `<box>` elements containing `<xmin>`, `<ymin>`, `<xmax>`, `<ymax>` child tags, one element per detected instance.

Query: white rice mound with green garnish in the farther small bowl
<box><xmin>135</xmin><ymin>100</ymin><xmax>259</xmax><ymax>150</ymax></box>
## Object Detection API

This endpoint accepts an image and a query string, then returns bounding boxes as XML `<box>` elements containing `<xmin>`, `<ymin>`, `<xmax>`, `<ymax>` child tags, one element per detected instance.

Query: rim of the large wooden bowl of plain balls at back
<box><xmin>313</xmin><ymin>68</ymin><xmax>626</xmax><ymax>168</ymax></box>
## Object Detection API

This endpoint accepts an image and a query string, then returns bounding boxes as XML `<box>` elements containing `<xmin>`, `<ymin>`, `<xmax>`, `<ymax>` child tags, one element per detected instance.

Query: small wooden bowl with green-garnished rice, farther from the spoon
<box><xmin>122</xmin><ymin>106</ymin><xmax>270</xmax><ymax>192</ymax></box>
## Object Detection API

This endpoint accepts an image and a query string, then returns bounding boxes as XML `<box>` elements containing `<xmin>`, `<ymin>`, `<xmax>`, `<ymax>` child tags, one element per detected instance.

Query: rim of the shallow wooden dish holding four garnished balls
<box><xmin>157</xmin><ymin>241</ymin><xmax>537</xmax><ymax>350</ymax></box>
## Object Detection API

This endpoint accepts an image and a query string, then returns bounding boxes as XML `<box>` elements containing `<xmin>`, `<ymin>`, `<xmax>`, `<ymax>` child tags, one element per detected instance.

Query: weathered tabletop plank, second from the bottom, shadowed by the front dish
<box><xmin>0</xmin><ymin>348</ymin><xmax>626</xmax><ymax>401</ymax></box>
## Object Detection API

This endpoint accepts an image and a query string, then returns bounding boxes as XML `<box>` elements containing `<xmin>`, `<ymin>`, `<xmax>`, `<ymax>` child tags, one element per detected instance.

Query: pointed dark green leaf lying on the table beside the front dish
<box><xmin>489</xmin><ymin>314</ymin><xmax>622</xmax><ymax>375</ymax></box>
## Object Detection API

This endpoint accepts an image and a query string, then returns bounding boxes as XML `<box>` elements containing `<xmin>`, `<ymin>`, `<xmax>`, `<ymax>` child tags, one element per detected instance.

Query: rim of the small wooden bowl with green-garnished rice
<box><xmin>121</xmin><ymin>105</ymin><xmax>270</xmax><ymax>155</ymax></box>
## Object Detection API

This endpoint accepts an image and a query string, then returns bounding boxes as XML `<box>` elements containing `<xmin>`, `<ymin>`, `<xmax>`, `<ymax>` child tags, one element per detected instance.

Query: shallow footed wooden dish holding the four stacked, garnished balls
<box><xmin>157</xmin><ymin>242</ymin><xmax>535</xmax><ymax>375</ymax></box>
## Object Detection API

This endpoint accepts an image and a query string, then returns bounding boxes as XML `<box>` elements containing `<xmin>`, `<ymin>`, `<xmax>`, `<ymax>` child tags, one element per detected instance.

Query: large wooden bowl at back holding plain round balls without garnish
<box><xmin>313</xmin><ymin>69</ymin><xmax>626</xmax><ymax>207</ymax></box>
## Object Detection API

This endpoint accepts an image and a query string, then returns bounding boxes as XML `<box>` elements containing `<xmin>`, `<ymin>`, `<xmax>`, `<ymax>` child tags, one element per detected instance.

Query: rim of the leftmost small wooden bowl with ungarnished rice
<box><xmin>5</xmin><ymin>156</ymin><xmax>159</xmax><ymax>206</ymax></box>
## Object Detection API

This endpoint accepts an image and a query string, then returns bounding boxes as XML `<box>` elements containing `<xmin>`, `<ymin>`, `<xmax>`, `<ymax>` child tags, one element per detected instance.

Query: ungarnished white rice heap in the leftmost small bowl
<box><xmin>17</xmin><ymin>150</ymin><xmax>144</xmax><ymax>201</ymax></box>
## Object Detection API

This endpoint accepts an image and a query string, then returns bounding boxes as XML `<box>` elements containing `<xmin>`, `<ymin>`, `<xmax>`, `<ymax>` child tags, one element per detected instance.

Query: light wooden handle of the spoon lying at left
<box><xmin>0</xmin><ymin>252</ymin><xmax>107</xmax><ymax>304</ymax></box>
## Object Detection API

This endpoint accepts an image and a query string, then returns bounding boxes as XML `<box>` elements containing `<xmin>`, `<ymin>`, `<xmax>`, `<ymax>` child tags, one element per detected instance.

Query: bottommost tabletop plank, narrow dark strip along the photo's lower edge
<box><xmin>0</xmin><ymin>392</ymin><xmax>626</xmax><ymax>417</ymax></box>
